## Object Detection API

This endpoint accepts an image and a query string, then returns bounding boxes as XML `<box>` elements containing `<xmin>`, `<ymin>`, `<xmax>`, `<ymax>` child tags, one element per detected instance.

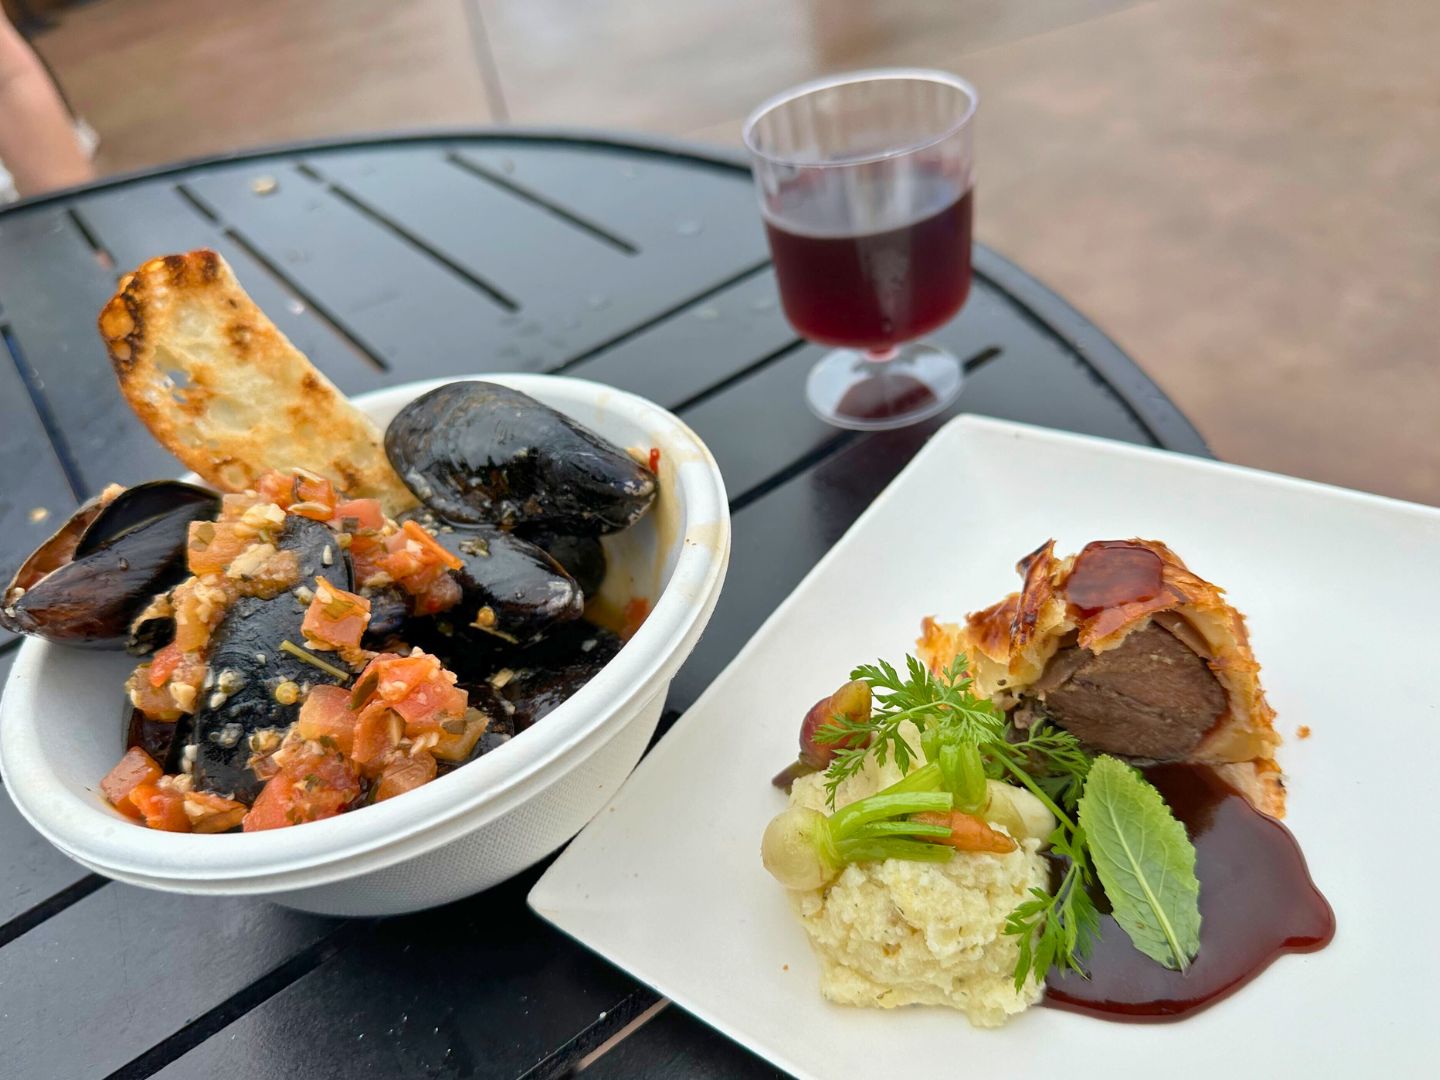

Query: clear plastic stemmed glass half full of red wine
<box><xmin>744</xmin><ymin>69</ymin><xmax>978</xmax><ymax>429</ymax></box>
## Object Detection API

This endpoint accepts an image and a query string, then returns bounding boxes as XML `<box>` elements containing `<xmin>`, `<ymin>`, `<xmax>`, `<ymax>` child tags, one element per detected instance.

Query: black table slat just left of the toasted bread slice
<box><xmin>0</xmin><ymin>207</ymin><xmax>181</xmax><ymax>492</ymax></box>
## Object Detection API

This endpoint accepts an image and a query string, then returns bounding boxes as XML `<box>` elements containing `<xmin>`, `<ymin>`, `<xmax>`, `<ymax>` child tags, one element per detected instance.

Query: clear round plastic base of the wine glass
<box><xmin>805</xmin><ymin>343</ymin><xmax>965</xmax><ymax>431</ymax></box>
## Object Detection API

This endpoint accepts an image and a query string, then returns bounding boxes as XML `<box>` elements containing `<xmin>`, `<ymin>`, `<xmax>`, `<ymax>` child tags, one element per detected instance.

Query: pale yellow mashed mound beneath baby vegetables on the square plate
<box><xmin>791</xmin><ymin>737</ymin><xmax>1048</xmax><ymax>1028</ymax></box>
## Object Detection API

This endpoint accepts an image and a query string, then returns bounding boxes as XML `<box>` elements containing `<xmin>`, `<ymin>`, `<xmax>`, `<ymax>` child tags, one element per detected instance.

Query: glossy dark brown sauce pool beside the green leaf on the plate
<box><xmin>1045</xmin><ymin>765</ymin><xmax>1335</xmax><ymax>1022</ymax></box>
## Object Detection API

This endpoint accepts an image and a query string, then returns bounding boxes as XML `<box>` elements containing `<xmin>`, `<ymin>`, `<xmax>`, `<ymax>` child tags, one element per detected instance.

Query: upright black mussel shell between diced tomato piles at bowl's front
<box><xmin>192</xmin><ymin>517</ymin><xmax>351</xmax><ymax>804</ymax></box>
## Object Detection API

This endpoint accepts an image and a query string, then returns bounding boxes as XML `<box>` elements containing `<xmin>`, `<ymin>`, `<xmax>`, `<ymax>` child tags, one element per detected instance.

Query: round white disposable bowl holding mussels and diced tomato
<box><xmin>0</xmin><ymin>374</ymin><xmax>730</xmax><ymax>916</ymax></box>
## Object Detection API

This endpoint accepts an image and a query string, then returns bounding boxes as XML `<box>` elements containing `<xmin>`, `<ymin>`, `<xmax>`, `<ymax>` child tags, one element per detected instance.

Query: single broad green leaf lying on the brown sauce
<box><xmin>1080</xmin><ymin>755</ymin><xmax>1200</xmax><ymax>971</ymax></box>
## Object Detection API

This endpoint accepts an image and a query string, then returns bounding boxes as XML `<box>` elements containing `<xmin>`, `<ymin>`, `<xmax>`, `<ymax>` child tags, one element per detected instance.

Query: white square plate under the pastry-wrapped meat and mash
<box><xmin>530</xmin><ymin>416</ymin><xmax>1440</xmax><ymax>1080</ymax></box>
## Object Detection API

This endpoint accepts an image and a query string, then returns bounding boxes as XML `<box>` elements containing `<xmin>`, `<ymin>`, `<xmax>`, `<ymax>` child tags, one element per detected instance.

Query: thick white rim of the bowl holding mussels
<box><xmin>0</xmin><ymin>373</ymin><xmax>730</xmax><ymax>891</ymax></box>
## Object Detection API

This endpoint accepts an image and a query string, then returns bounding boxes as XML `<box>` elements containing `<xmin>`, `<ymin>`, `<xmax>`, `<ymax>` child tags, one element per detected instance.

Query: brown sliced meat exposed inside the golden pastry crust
<box><xmin>1040</xmin><ymin>624</ymin><xmax>1225</xmax><ymax>762</ymax></box>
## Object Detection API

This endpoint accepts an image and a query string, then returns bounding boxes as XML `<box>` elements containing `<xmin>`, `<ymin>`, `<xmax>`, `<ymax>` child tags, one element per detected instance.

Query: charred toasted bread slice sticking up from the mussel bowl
<box><xmin>99</xmin><ymin>249</ymin><xmax>416</xmax><ymax>516</ymax></box>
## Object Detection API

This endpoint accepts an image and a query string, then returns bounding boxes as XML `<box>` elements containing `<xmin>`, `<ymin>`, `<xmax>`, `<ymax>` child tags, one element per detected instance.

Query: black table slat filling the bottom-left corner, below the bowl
<box><xmin>0</xmin><ymin>883</ymin><xmax>341</xmax><ymax>1080</ymax></box>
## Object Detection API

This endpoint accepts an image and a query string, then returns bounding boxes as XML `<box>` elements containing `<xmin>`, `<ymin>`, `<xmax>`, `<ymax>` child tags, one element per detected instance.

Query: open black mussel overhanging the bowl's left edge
<box><xmin>0</xmin><ymin>480</ymin><xmax>220</xmax><ymax>648</ymax></box>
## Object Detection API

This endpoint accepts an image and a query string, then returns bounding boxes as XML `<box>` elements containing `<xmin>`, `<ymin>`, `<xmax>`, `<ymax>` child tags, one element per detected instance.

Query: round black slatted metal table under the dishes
<box><xmin>0</xmin><ymin>130</ymin><xmax>1205</xmax><ymax>1080</ymax></box>
